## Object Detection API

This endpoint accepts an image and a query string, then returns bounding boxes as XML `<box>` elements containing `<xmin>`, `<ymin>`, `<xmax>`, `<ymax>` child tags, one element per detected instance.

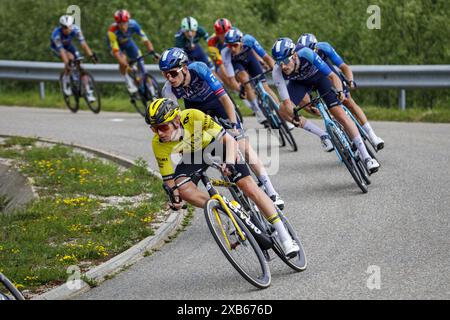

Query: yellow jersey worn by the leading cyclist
<box><xmin>152</xmin><ymin>109</ymin><xmax>225</xmax><ymax>181</ymax></box>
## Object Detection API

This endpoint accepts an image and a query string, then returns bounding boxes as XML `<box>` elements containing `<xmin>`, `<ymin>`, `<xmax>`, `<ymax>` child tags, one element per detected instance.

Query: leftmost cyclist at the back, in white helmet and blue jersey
<box><xmin>50</xmin><ymin>15</ymin><xmax>98</xmax><ymax>102</ymax></box>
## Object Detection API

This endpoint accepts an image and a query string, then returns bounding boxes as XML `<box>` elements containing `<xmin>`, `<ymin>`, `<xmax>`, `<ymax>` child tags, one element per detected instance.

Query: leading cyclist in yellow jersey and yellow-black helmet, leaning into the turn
<box><xmin>145</xmin><ymin>98</ymin><xmax>300</xmax><ymax>255</ymax></box>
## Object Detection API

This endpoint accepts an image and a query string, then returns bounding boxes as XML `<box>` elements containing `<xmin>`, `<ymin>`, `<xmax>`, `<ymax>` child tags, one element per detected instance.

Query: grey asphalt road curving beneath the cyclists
<box><xmin>0</xmin><ymin>107</ymin><xmax>450</xmax><ymax>299</ymax></box>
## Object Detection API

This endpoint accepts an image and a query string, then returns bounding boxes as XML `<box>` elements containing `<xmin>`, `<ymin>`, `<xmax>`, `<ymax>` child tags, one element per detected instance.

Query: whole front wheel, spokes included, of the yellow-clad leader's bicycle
<box><xmin>204</xmin><ymin>200</ymin><xmax>271</xmax><ymax>289</ymax></box>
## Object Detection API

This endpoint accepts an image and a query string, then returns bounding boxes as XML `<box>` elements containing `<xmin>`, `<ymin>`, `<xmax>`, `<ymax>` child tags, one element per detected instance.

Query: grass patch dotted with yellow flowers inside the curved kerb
<box><xmin>0</xmin><ymin>138</ymin><xmax>166</xmax><ymax>292</ymax></box>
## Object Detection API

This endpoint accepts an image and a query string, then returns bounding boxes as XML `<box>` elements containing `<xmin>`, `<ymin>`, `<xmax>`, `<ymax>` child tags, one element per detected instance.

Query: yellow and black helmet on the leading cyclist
<box><xmin>145</xmin><ymin>98</ymin><xmax>180</xmax><ymax>126</ymax></box>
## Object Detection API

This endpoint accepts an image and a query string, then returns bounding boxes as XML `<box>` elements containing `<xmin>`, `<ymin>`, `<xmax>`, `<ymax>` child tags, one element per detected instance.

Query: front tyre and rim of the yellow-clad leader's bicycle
<box><xmin>204</xmin><ymin>200</ymin><xmax>271</xmax><ymax>289</ymax></box>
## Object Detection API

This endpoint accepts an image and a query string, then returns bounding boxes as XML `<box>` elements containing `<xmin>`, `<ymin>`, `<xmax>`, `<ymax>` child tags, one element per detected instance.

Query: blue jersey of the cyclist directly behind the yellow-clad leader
<box><xmin>163</xmin><ymin>62</ymin><xmax>225</xmax><ymax>107</ymax></box>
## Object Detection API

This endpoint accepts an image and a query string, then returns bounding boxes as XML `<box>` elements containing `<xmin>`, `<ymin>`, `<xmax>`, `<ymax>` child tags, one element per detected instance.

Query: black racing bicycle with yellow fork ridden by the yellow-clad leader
<box><xmin>163</xmin><ymin>158</ymin><xmax>307</xmax><ymax>289</ymax></box>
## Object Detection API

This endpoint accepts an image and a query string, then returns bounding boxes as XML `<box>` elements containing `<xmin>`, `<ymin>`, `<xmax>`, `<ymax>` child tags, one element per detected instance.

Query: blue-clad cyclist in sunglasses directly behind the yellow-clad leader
<box><xmin>159</xmin><ymin>48</ymin><xmax>284</xmax><ymax>209</ymax></box>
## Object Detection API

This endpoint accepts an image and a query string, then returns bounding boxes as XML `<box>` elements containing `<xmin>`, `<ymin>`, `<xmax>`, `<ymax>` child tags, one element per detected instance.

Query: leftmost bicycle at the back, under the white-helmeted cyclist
<box><xmin>59</xmin><ymin>57</ymin><xmax>101</xmax><ymax>113</ymax></box>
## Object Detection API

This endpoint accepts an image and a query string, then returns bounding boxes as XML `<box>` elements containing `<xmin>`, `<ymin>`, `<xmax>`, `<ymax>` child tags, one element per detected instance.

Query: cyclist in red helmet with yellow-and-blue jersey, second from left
<box><xmin>108</xmin><ymin>9</ymin><xmax>159</xmax><ymax>94</ymax></box>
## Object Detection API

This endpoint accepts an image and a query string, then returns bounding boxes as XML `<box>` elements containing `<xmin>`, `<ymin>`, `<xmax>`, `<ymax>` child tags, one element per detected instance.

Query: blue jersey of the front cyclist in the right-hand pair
<box><xmin>283</xmin><ymin>44</ymin><xmax>332</xmax><ymax>80</ymax></box>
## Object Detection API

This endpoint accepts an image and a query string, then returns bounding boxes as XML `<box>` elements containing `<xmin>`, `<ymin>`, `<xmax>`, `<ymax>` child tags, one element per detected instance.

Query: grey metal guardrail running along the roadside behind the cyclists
<box><xmin>0</xmin><ymin>60</ymin><xmax>450</xmax><ymax>110</ymax></box>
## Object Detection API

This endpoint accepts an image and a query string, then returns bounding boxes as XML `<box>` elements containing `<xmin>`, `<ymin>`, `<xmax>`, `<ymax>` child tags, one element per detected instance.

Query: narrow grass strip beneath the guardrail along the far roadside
<box><xmin>0</xmin><ymin>90</ymin><xmax>450</xmax><ymax>123</ymax></box>
